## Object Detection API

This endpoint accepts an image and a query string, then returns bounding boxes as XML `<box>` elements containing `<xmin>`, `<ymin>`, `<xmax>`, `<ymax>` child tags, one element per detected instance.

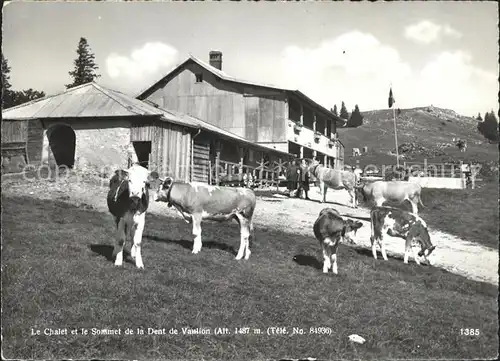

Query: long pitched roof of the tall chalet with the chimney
<box><xmin>137</xmin><ymin>55</ymin><xmax>346</xmax><ymax>126</ymax></box>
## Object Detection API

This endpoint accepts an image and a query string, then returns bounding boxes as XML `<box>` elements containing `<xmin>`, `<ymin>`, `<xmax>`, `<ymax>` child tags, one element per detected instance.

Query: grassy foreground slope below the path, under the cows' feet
<box><xmin>2</xmin><ymin>195</ymin><xmax>498</xmax><ymax>360</ymax></box>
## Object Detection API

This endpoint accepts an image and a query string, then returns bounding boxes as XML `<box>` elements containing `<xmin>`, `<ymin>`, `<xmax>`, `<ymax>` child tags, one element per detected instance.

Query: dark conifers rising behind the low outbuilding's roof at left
<box><xmin>2</xmin><ymin>38</ymin><xmax>100</xmax><ymax>109</ymax></box>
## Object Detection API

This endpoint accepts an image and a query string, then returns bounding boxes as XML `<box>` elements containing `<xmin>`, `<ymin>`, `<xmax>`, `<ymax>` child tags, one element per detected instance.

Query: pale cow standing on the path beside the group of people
<box><xmin>306</xmin><ymin>159</ymin><xmax>361</xmax><ymax>208</ymax></box>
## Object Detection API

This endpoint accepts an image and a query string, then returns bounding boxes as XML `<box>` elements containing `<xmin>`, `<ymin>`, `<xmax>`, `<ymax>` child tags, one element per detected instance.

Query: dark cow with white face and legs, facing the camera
<box><xmin>107</xmin><ymin>164</ymin><xmax>158</xmax><ymax>269</ymax></box>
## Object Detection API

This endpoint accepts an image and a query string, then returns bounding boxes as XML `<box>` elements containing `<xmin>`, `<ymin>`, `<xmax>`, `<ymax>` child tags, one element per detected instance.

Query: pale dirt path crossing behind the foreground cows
<box><xmin>2</xmin><ymin>178</ymin><xmax>499</xmax><ymax>285</ymax></box>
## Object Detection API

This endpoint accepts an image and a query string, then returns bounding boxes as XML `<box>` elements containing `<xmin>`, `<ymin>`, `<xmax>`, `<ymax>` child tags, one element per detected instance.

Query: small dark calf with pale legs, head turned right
<box><xmin>313</xmin><ymin>208</ymin><xmax>363</xmax><ymax>274</ymax></box>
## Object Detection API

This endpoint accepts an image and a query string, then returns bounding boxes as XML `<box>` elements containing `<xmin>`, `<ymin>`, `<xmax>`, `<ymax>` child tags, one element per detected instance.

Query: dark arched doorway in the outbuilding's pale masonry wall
<box><xmin>47</xmin><ymin>124</ymin><xmax>76</xmax><ymax>168</ymax></box>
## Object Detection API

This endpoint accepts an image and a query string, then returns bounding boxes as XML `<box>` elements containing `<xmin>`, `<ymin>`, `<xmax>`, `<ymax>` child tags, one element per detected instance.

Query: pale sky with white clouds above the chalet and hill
<box><xmin>2</xmin><ymin>1</ymin><xmax>499</xmax><ymax>116</ymax></box>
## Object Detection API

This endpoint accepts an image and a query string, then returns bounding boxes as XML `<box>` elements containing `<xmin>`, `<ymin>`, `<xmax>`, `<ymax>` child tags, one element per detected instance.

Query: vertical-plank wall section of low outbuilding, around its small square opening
<box><xmin>130</xmin><ymin>122</ymin><xmax>191</xmax><ymax>182</ymax></box>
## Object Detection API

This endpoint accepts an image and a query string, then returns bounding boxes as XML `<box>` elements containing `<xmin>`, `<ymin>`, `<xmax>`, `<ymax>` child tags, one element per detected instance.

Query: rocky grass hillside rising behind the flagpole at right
<box><xmin>339</xmin><ymin>106</ymin><xmax>498</xmax><ymax>172</ymax></box>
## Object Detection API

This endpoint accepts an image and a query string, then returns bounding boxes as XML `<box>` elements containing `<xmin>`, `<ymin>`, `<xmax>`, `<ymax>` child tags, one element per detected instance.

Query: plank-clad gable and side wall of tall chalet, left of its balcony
<box><xmin>143</xmin><ymin>62</ymin><xmax>288</xmax><ymax>142</ymax></box>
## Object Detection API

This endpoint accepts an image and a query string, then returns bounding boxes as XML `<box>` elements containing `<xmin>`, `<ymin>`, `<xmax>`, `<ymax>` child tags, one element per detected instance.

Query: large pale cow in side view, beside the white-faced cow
<box><xmin>154</xmin><ymin>177</ymin><xmax>256</xmax><ymax>260</ymax></box>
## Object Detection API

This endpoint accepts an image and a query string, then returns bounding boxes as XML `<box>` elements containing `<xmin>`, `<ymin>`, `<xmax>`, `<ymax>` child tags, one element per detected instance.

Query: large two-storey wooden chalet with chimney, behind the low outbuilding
<box><xmin>138</xmin><ymin>51</ymin><xmax>345</xmax><ymax>169</ymax></box>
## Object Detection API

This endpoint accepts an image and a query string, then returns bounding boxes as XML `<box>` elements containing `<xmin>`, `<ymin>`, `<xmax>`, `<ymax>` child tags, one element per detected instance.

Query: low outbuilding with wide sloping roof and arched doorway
<box><xmin>2</xmin><ymin>82</ymin><xmax>292</xmax><ymax>183</ymax></box>
